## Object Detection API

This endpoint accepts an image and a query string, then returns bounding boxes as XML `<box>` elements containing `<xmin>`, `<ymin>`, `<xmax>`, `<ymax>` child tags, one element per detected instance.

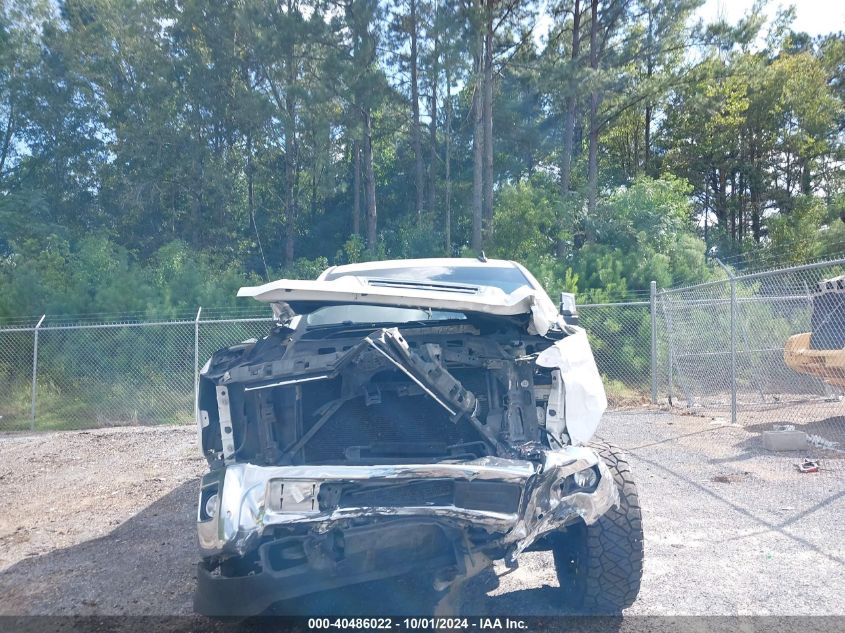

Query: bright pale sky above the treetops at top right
<box><xmin>698</xmin><ymin>0</ymin><xmax>845</xmax><ymax>35</ymax></box>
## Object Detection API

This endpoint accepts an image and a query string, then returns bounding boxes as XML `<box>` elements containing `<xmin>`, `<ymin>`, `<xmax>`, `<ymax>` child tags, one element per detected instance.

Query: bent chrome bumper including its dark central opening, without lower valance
<box><xmin>199</xmin><ymin>447</ymin><xmax>617</xmax><ymax>556</ymax></box>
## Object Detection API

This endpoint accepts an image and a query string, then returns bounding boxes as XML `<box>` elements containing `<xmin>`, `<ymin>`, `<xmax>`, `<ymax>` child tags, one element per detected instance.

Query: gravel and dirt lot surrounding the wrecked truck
<box><xmin>0</xmin><ymin>412</ymin><xmax>845</xmax><ymax>615</ymax></box>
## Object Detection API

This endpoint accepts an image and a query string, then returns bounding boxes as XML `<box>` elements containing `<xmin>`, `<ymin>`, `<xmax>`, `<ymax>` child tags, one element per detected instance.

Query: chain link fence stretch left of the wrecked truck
<box><xmin>0</xmin><ymin>314</ymin><xmax>272</xmax><ymax>431</ymax></box>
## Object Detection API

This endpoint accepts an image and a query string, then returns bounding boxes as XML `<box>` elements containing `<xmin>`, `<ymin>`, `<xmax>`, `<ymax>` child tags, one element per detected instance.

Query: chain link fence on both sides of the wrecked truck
<box><xmin>0</xmin><ymin>259</ymin><xmax>845</xmax><ymax>440</ymax></box>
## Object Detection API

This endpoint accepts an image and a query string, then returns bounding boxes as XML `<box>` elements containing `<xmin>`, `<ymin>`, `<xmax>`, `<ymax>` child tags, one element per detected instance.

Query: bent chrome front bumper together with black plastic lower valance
<box><xmin>194</xmin><ymin>447</ymin><xmax>619</xmax><ymax>615</ymax></box>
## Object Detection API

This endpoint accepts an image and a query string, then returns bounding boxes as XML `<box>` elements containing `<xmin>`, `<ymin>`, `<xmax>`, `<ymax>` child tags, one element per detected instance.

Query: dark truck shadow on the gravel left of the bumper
<box><xmin>0</xmin><ymin>481</ymin><xmax>198</xmax><ymax>615</ymax></box>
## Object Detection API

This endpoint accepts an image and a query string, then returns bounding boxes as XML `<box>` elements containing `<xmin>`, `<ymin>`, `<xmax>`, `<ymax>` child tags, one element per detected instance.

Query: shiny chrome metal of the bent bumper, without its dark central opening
<box><xmin>198</xmin><ymin>447</ymin><xmax>618</xmax><ymax>556</ymax></box>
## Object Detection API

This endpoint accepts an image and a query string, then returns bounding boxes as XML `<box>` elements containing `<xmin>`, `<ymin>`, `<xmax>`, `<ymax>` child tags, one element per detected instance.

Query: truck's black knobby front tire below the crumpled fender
<box><xmin>550</xmin><ymin>442</ymin><xmax>643</xmax><ymax>613</ymax></box>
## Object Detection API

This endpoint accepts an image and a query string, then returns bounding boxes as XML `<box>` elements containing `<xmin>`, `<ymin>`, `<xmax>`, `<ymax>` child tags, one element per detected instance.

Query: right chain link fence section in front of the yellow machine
<box><xmin>657</xmin><ymin>259</ymin><xmax>845</xmax><ymax>450</ymax></box>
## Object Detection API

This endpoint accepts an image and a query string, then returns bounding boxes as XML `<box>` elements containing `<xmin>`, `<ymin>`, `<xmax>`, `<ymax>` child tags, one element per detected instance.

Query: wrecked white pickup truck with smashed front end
<box><xmin>194</xmin><ymin>259</ymin><xmax>643</xmax><ymax>615</ymax></box>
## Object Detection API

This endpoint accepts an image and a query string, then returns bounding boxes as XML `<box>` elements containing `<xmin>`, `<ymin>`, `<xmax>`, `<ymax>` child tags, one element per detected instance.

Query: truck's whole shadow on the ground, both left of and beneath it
<box><xmin>0</xmin><ymin>482</ymin><xmax>572</xmax><ymax>616</ymax></box>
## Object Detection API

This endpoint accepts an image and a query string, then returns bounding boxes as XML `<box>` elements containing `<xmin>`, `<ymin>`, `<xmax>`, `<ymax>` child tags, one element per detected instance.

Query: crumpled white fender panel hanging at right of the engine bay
<box><xmin>537</xmin><ymin>328</ymin><xmax>607</xmax><ymax>445</ymax></box>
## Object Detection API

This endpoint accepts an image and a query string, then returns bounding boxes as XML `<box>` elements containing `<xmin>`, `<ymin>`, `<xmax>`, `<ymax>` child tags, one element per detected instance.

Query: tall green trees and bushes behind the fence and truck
<box><xmin>0</xmin><ymin>0</ymin><xmax>845</xmax><ymax>317</ymax></box>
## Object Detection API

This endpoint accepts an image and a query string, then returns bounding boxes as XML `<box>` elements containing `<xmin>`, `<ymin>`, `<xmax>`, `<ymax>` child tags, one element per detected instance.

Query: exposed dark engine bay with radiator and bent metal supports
<box><xmin>198</xmin><ymin>322</ymin><xmax>566</xmax><ymax>468</ymax></box>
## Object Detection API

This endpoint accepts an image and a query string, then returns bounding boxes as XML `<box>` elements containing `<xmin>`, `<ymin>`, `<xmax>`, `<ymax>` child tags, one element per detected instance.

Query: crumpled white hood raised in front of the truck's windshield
<box><xmin>238</xmin><ymin>276</ymin><xmax>559</xmax><ymax>336</ymax></box>
